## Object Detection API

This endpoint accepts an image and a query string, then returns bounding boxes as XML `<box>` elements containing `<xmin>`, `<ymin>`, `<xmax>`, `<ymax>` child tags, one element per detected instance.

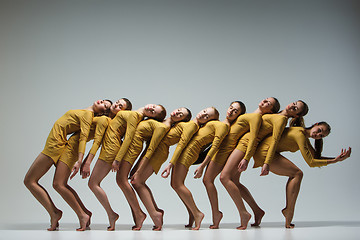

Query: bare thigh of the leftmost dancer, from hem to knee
<box><xmin>25</xmin><ymin>153</ymin><xmax>54</xmax><ymax>181</ymax></box>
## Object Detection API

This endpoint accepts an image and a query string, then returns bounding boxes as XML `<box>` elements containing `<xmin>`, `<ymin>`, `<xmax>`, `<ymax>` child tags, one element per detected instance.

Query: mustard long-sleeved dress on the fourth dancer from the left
<box><xmin>119</xmin><ymin>119</ymin><xmax>170</xmax><ymax>164</ymax></box>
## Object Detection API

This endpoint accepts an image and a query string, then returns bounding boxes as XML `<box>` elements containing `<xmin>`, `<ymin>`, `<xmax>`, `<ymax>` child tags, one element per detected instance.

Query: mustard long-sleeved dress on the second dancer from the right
<box><xmin>236</xmin><ymin>114</ymin><xmax>288</xmax><ymax>164</ymax></box>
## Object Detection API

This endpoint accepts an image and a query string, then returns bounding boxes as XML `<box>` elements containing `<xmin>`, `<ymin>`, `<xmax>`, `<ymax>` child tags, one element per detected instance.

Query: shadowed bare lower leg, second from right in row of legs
<box><xmin>232</xmin><ymin>171</ymin><xmax>265</xmax><ymax>227</ymax></box>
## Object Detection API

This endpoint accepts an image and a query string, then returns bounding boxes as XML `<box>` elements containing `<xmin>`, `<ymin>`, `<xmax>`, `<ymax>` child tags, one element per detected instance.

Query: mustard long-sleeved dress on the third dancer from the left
<box><xmin>99</xmin><ymin>111</ymin><xmax>143</xmax><ymax>165</ymax></box>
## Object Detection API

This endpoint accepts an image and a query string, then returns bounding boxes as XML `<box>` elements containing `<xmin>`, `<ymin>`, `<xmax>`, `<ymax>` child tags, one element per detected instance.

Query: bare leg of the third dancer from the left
<box><xmin>88</xmin><ymin>159</ymin><xmax>119</xmax><ymax>231</ymax></box>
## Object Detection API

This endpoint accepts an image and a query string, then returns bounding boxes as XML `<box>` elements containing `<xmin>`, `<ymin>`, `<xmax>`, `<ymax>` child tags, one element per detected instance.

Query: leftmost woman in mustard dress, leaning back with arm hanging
<box><xmin>24</xmin><ymin>100</ymin><xmax>111</xmax><ymax>231</ymax></box>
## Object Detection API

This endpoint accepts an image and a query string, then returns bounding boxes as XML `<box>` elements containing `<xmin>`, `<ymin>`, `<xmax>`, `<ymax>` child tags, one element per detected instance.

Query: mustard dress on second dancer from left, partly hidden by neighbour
<box><xmin>59</xmin><ymin>116</ymin><xmax>111</xmax><ymax>171</ymax></box>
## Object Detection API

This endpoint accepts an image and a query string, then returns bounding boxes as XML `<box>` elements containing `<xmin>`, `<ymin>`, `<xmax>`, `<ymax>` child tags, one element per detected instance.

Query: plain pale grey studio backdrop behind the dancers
<box><xmin>0</xmin><ymin>0</ymin><xmax>360</xmax><ymax>224</ymax></box>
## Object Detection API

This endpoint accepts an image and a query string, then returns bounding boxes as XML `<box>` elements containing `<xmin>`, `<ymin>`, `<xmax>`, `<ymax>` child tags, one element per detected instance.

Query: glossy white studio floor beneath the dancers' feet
<box><xmin>0</xmin><ymin>221</ymin><xmax>360</xmax><ymax>240</ymax></box>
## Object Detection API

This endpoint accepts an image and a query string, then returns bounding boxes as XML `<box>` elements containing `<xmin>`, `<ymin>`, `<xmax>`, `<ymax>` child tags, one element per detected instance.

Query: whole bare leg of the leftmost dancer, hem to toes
<box><xmin>24</xmin><ymin>153</ymin><xmax>62</xmax><ymax>231</ymax></box>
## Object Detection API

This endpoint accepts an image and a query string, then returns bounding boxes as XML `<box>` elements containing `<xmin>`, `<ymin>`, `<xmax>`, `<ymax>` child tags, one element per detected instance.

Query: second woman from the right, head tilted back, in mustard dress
<box><xmin>220</xmin><ymin>100</ymin><xmax>308</xmax><ymax>230</ymax></box>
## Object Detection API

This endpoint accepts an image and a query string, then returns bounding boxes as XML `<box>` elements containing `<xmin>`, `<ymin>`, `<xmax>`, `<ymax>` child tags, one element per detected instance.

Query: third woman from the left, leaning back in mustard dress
<box><xmin>87</xmin><ymin>104</ymin><xmax>165</xmax><ymax>231</ymax></box>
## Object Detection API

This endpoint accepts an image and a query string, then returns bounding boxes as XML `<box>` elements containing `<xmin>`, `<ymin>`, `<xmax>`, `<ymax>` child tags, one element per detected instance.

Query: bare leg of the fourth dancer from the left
<box><xmin>116</xmin><ymin>161</ymin><xmax>146</xmax><ymax>231</ymax></box>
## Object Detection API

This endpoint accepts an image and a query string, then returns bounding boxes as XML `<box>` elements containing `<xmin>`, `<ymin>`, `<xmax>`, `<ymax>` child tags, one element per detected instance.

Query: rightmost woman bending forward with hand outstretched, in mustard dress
<box><xmin>254</xmin><ymin>122</ymin><xmax>351</xmax><ymax>228</ymax></box>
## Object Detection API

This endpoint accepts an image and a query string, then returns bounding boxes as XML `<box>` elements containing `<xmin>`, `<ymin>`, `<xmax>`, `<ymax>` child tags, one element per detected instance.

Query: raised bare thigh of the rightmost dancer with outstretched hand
<box><xmin>270</xmin><ymin>153</ymin><xmax>300</xmax><ymax>177</ymax></box>
